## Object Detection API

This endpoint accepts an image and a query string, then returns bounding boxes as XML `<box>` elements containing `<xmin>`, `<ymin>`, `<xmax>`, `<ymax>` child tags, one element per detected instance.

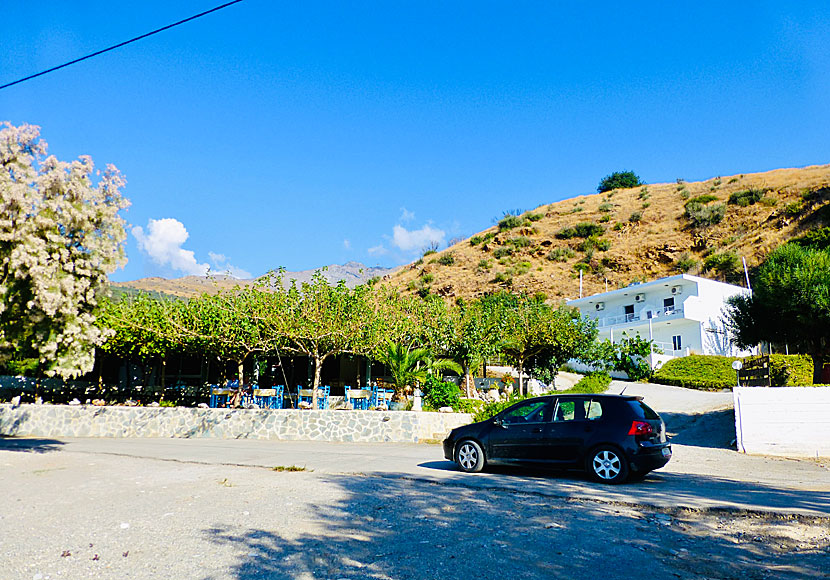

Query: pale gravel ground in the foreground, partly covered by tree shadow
<box><xmin>0</xmin><ymin>450</ymin><xmax>830</xmax><ymax>580</ymax></box>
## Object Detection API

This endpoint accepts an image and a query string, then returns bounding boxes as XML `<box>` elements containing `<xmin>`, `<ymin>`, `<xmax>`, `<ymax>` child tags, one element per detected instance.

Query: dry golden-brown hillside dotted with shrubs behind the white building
<box><xmin>386</xmin><ymin>165</ymin><xmax>830</xmax><ymax>300</ymax></box>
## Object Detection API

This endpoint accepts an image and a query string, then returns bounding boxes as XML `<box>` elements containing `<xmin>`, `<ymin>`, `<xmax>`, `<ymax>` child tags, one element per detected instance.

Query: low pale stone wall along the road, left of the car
<box><xmin>0</xmin><ymin>403</ymin><xmax>471</xmax><ymax>443</ymax></box>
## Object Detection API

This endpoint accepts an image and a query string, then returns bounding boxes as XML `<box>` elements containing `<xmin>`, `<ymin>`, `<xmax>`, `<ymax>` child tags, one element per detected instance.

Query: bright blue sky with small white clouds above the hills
<box><xmin>0</xmin><ymin>0</ymin><xmax>830</xmax><ymax>280</ymax></box>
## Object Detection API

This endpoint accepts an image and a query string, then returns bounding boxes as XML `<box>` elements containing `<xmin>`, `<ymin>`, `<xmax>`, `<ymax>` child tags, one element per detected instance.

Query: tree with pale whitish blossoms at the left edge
<box><xmin>0</xmin><ymin>122</ymin><xmax>129</xmax><ymax>378</ymax></box>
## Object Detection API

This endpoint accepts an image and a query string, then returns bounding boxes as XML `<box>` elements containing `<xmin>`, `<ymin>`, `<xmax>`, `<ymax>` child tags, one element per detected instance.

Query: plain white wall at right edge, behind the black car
<box><xmin>732</xmin><ymin>387</ymin><xmax>830</xmax><ymax>457</ymax></box>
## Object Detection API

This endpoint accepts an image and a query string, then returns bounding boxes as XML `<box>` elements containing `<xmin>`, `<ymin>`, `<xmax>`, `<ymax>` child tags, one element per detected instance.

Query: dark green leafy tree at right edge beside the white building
<box><xmin>726</xmin><ymin>244</ymin><xmax>830</xmax><ymax>384</ymax></box>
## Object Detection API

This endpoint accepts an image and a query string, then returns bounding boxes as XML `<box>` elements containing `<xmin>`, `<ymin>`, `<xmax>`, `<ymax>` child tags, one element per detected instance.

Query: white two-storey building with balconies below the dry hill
<box><xmin>568</xmin><ymin>274</ymin><xmax>752</xmax><ymax>367</ymax></box>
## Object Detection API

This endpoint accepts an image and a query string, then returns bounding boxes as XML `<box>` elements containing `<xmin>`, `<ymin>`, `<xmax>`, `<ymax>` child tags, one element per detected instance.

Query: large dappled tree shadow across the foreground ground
<box><xmin>203</xmin><ymin>474</ymin><xmax>830</xmax><ymax>580</ymax></box>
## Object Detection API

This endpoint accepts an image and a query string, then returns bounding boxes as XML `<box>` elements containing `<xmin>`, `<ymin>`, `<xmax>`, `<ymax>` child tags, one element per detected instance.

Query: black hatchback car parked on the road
<box><xmin>444</xmin><ymin>394</ymin><xmax>671</xmax><ymax>483</ymax></box>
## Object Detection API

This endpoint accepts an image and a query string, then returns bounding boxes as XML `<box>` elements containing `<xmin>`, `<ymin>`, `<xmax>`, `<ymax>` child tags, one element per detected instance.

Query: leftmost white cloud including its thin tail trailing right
<box><xmin>131</xmin><ymin>218</ymin><xmax>251</xmax><ymax>278</ymax></box>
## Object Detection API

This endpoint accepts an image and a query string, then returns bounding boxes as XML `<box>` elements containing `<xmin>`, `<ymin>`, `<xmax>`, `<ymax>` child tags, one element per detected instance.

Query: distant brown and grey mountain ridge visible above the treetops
<box><xmin>111</xmin><ymin>262</ymin><xmax>397</xmax><ymax>298</ymax></box>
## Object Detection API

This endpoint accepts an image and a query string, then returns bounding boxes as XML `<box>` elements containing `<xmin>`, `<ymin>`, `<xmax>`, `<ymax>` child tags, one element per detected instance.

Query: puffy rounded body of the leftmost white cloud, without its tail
<box><xmin>132</xmin><ymin>218</ymin><xmax>210</xmax><ymax>276</ymax></box>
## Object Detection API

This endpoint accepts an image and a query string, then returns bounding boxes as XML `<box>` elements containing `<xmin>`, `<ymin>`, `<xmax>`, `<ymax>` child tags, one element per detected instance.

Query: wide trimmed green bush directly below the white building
<box><xmin>651</xmin><ymin>354</ymin><xmax>738</xmax><ymax>391</ymax></box>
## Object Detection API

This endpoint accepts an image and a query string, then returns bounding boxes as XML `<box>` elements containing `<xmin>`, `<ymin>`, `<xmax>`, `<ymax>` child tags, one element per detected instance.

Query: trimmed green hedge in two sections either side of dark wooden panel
<box><xmin>651</xmin><ymin>354</ymin><xmax>813</xmax><ymax>391</ymax></box>
